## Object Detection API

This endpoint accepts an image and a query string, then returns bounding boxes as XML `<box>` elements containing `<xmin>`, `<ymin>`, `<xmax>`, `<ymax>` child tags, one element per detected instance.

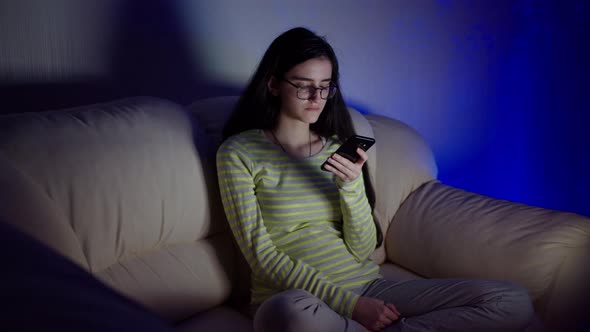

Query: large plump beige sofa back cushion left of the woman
<box><xmin>0</xmin><ymin>98</ymin><xmax>233</xmax><ymax>321</ymax></box>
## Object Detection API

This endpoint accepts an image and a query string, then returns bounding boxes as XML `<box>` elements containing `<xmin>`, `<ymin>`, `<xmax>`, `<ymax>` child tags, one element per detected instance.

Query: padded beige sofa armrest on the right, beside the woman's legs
<box><xmin>385</xmin><ymin>181</ymin><xmax>590</xmax><ymax>318</ymax></box>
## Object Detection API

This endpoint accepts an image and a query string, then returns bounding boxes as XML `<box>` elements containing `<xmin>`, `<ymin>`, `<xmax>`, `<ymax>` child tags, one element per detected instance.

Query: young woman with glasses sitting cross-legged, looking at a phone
<box><xmin>217</xmin><ymin>28</ymin><xmax>532</xmax><ymax>331</ymax></box>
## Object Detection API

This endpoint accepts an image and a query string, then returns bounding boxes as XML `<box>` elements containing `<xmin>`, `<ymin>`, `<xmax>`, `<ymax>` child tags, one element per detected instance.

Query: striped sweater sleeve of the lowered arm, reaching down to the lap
<box><xmin>217</xmin><ymin>141</ymin><xmax>359</xmax><ymax>318</ymax></box>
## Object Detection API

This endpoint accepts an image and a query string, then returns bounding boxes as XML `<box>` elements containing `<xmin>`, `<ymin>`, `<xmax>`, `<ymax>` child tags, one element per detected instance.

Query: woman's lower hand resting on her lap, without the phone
<box><xmin>352</xmin><ymin>296</ymin><xmax>400</xmax><ymax>331</ymax></box>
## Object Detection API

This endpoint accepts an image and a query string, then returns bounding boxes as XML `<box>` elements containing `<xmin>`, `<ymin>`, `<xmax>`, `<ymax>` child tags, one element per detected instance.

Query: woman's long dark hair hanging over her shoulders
<box><xmin>223</xmin><ymin>27</ymin><xmax>383</xmax><ymax>247</ymax></box>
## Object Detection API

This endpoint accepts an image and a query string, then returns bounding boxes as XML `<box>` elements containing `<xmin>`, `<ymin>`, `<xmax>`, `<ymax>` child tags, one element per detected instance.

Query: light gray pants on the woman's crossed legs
<box><xmin>254</xmin><ymin>279</ymin><xmax>533</xmax><ymax>332</ymax></box>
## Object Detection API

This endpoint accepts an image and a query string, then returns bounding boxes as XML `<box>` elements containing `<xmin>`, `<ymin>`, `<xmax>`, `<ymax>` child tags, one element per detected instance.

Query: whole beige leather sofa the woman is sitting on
<box><xmin>0</xmin><ymin>97</ymin><xmax>590</xmax><ymax>332</ymax></box>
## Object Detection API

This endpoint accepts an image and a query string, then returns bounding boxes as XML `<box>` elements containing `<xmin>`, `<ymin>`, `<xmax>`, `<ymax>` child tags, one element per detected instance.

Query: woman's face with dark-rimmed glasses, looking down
<box><xmin>268</xmin><ymin>57</ymin><xmax>332</xmax><ymax>124</ymax></box>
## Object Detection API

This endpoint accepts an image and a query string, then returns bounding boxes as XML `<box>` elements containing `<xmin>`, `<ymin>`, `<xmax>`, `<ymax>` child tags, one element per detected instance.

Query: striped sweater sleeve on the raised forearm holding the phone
<box><xmin>336</xmin><ymin>175</ymin><xmax>377</xmax><ymax>262</ymax></box>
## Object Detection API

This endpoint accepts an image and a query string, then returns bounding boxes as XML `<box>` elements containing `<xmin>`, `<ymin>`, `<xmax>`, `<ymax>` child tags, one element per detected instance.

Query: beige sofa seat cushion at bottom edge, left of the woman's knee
<box><xmin>176</xmin><ymin>306</ymin><xmax>254</xmax><ymax>332</ymax></box>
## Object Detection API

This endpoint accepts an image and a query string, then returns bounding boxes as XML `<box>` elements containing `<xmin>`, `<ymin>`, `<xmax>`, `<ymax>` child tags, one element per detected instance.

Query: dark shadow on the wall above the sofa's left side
<box><xmin>0</xmin><ymin>0</ymin><xmax>241</xmax><ymax>113</ymax></box>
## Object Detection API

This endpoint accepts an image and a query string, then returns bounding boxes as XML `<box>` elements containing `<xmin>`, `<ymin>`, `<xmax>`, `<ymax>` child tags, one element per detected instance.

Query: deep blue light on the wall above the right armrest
<box><xmin>437</xmin><ymin>1</ymin><xmax>590</xmax><ymax>215</ymax></box>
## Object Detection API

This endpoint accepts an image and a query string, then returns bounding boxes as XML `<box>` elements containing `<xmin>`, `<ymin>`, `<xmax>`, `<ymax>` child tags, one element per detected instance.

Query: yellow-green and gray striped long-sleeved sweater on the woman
<box><xmin>217</xmin><ymin>129</ymin><xmax>380</xmax><ymax>317</ymax></box>
